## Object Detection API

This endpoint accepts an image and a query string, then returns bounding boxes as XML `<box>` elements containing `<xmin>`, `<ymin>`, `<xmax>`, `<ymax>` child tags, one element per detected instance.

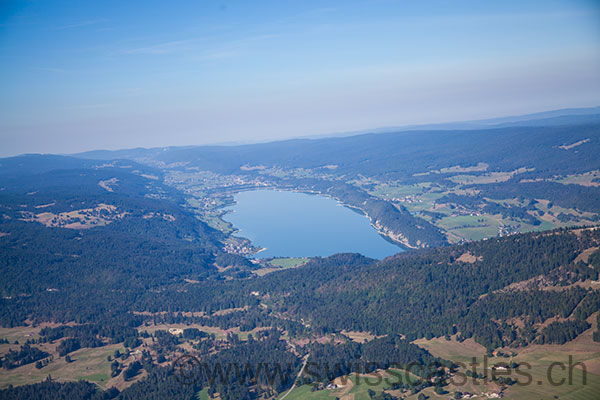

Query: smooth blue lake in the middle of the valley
<box><xmin>224</xmin><ymin>190</ymin><xmax>403</xmax><ymax>259</ymax></box>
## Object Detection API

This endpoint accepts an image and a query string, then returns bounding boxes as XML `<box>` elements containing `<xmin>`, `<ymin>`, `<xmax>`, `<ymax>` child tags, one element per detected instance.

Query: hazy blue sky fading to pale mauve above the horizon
<box><xmin>0</xmin><ymin>0</ymin><xmax>600</xmax><ymax>156</ymax></box>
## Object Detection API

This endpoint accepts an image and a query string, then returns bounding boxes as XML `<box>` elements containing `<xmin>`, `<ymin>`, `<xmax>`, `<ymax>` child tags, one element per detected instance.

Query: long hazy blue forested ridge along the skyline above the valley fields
<box><xmin>81</xmin><ymin>123</ymin><xmax>600</xmax><ymax>180</ymax></box>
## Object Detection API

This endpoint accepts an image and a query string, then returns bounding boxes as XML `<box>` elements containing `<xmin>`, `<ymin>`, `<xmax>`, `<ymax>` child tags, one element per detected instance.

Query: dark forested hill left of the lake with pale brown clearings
<box><xmin>0</xmin><ymin>157</ymin><xmax>220</xmax><ymax>326</ymax></box>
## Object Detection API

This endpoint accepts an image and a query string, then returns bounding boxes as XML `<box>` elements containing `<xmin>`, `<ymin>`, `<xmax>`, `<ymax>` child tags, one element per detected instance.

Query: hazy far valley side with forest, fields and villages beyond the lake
<box><xmin>75</xmin><ymin>118</ymin><xmax>600</xmax><ymax>248</ymax></box>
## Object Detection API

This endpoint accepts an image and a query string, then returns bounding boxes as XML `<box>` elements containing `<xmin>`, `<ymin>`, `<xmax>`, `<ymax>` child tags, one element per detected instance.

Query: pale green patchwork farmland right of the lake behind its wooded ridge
<box><xmin>349</xmin><ymin>177</ymin><xmax>600</xmax><ymax>243</ymax></box>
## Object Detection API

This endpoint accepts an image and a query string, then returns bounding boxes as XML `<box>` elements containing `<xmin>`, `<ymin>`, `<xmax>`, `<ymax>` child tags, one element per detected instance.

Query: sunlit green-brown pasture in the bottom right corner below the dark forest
<box><xmin>279</xmin><ymin>330</ymin><xmax>600</xmax><ymax>400</ymax></box>
